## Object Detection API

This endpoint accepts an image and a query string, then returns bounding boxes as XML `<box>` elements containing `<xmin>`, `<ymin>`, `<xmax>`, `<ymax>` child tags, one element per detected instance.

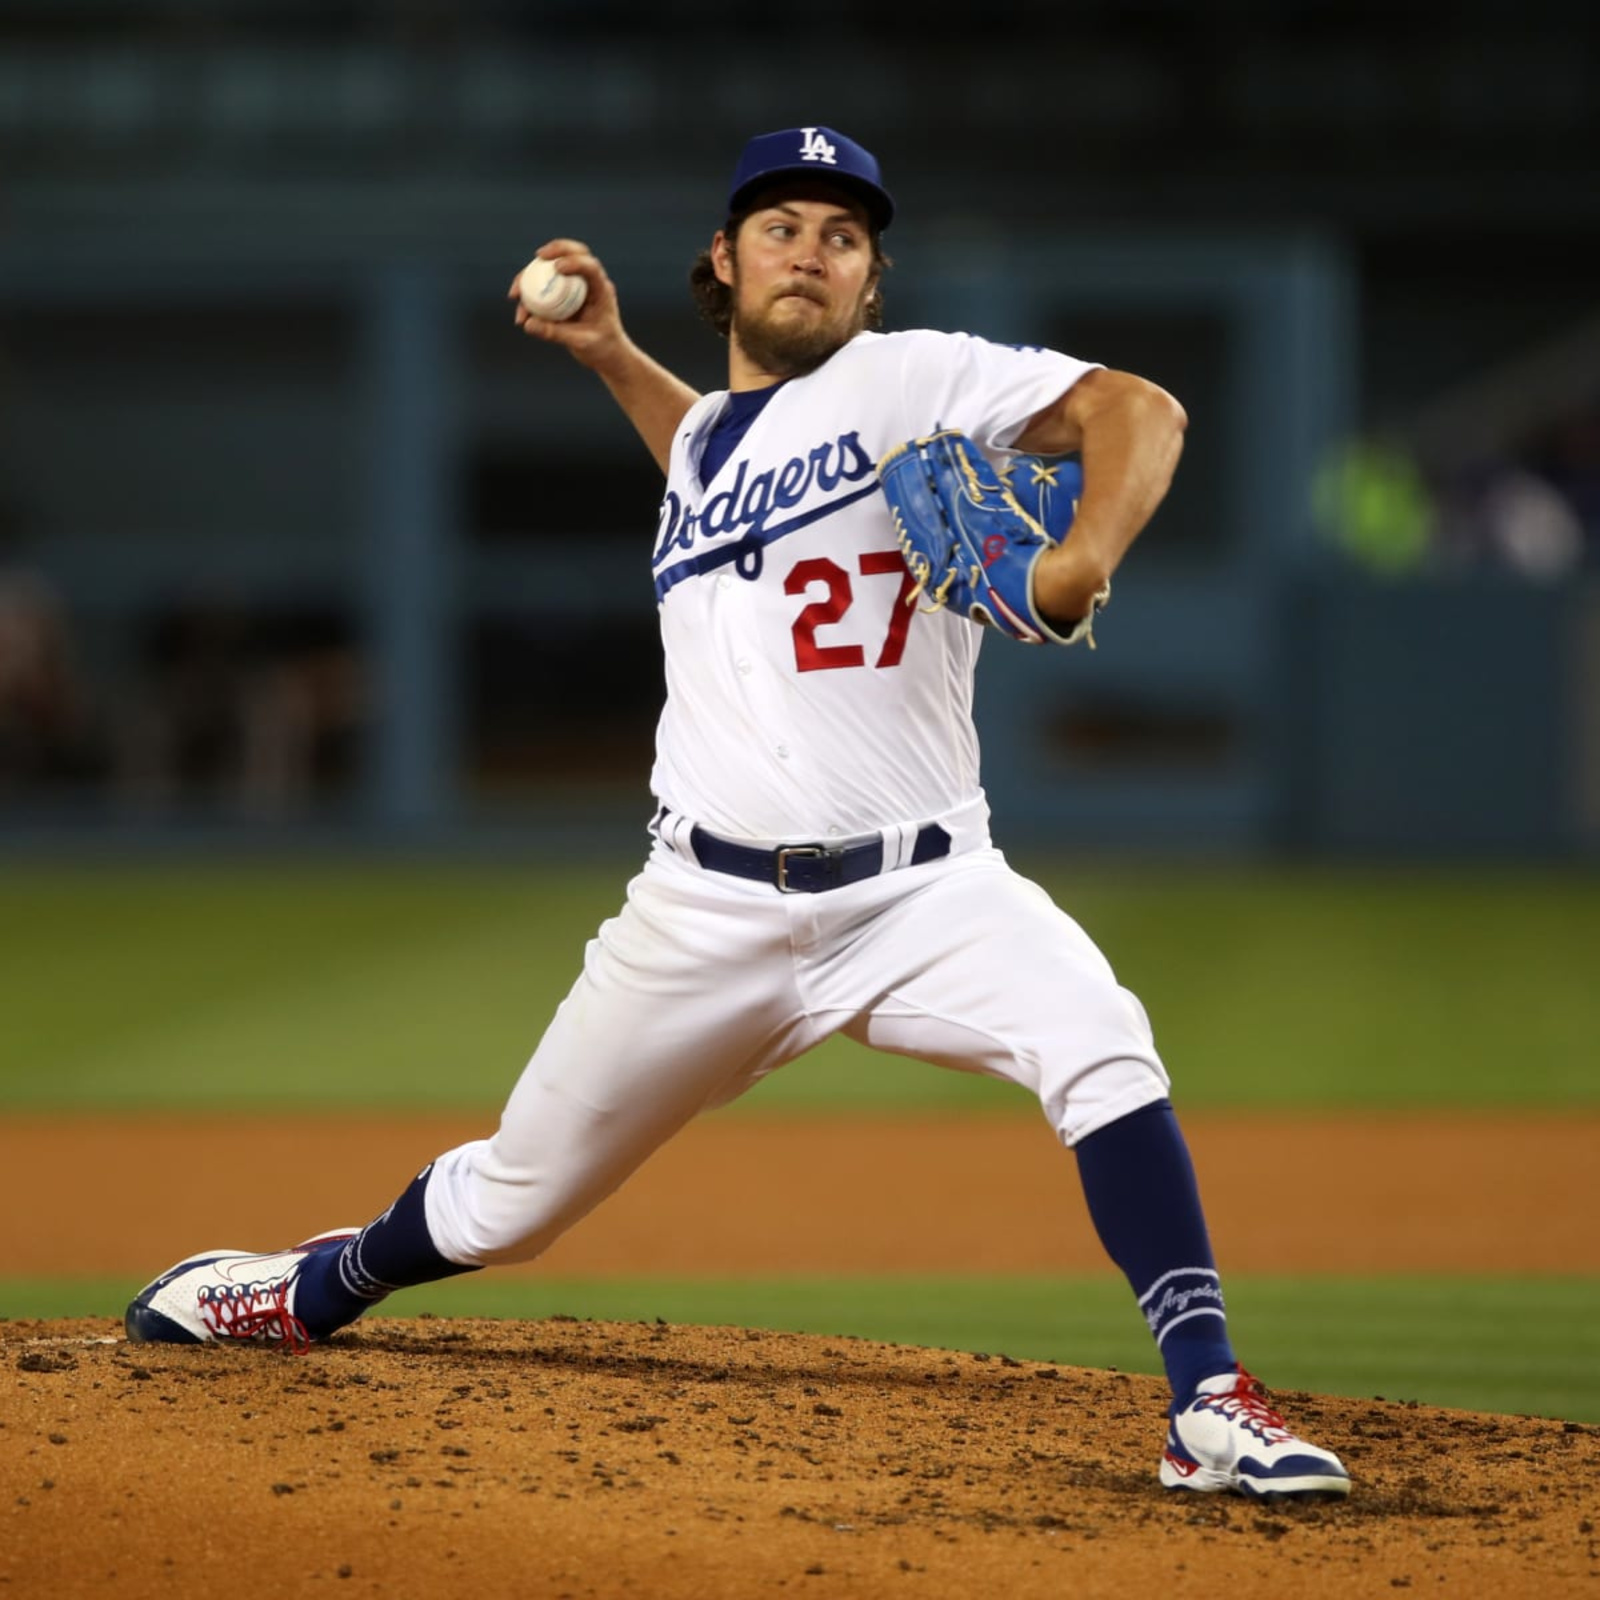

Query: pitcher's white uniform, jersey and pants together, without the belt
<box><xmin>427</xmin><ymin>333</ymin><xmax>1168</xmax><ymax>1266</ymax></box>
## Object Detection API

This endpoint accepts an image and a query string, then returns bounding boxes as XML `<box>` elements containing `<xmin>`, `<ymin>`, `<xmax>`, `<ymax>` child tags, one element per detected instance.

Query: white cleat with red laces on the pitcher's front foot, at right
<box><xmin>1162</xmin><ymin>1366</ymin><xmax>1350</xmax><ymax>1499</ymax></box>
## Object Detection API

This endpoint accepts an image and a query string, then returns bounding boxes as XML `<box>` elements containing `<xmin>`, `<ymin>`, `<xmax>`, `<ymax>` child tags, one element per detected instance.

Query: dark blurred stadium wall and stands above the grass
<box><xmin>0</xmin><ymin>0</ymin><xmax>1600</xmax><ymax>859</ymax></box>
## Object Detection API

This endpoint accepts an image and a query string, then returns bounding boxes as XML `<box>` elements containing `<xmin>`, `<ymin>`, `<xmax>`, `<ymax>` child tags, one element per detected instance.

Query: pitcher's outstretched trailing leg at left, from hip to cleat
<box><xmin>125</xmin><ymin>861</ymin><xmax>816</xmax><ymax>1349</ymax></box>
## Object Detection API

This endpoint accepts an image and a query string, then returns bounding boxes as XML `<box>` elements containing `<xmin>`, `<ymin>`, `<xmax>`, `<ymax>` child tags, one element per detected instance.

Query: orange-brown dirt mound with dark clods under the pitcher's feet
<box><xmin>9</xmin><ymin>1318</ymin><xmax>1600</xmax><ymax>1600</ymax></box>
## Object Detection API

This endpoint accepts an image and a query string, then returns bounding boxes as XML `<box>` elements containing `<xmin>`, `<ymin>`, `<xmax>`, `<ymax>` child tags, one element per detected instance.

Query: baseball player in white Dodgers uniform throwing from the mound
<box><xmin>126</xmin><ymin>126</ymin><xmax>1349</xmax><ymax>1498</ymax></box>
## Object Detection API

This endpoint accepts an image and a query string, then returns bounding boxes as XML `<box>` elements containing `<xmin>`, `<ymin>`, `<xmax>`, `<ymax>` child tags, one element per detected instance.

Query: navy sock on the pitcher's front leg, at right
<box><xmin>1074</xmin><ymin>1099</ymin><xmax>1237</xmax><ymax>1405</ymax></box>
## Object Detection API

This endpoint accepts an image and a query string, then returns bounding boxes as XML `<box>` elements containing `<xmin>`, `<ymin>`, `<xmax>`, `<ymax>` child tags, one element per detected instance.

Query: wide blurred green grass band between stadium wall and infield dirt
<box><xmin>0</xmin><ymin>861</ymin><xmax>1600</xmax><ymax>1110</ymax></box>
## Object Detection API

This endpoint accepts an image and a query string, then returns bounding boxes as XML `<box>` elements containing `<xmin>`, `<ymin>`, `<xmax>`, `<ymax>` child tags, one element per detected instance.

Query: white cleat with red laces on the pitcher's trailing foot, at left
<box><xmin>123</xmin><ymin>1227</ymin><xmax>360</xmax><ymax>1352</ymax></box>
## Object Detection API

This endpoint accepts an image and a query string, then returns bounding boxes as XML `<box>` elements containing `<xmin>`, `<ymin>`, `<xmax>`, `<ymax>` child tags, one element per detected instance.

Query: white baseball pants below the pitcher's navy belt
<box><xmin>426</xmin><ymin>838</ymin><xmax>1170</xmax><ymax>1266</ymax></box>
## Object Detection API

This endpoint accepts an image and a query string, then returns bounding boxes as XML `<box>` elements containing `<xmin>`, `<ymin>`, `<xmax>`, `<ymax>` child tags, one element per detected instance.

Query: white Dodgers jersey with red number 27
<box><xmin>651</xmin><ymin>331</ymin><xmax>1091</xmax><ymax>842</ymax></box>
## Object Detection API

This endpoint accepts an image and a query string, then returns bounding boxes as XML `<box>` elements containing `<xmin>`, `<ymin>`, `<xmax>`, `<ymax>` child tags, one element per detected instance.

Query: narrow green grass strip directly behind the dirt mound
<box><xmin>9</xmin><ymin>1274</ymin><xmax>1600</xmax><ymax>1422</ymax></box>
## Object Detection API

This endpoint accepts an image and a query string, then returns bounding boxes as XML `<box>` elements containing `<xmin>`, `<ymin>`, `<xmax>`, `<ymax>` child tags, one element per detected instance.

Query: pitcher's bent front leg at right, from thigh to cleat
<box><xmin>838</xmin><ymin>851</ymin><xmax>1349</xmax><ymax>1496</ymax></box>
